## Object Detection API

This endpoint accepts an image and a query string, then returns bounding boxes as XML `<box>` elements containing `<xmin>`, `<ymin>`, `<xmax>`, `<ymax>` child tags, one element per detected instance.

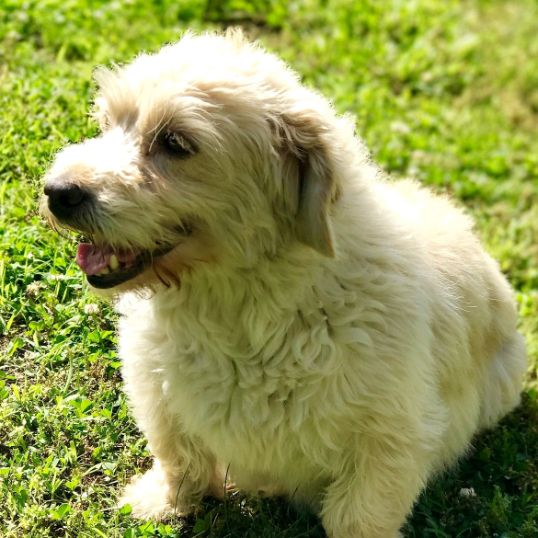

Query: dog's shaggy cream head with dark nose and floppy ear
<box><xmin>42</xmin><ymin>34</ymin><xmax>337</xmax><ymax>290</ymax></box>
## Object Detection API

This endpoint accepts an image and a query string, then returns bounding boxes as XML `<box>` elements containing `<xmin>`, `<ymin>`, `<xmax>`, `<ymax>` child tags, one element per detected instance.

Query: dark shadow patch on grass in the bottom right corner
<box><xmin>404</xmin><ymin>391</ymin><xmax>538</xmax><ymax>538</ymax></box>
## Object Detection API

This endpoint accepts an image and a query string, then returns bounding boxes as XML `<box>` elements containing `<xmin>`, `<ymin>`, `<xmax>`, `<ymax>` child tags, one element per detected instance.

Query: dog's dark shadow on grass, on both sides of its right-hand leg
<box><xmin>174</xmin><ymin>392</ymin><xmax>538</xmax><ymax>538</ymax></box>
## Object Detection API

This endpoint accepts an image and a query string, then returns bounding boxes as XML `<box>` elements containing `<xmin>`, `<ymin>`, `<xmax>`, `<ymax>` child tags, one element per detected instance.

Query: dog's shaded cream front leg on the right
<box><xmin>321</xmin><ymin>440</ymin><xmax>427</xmax><ymax>538</ymax></box>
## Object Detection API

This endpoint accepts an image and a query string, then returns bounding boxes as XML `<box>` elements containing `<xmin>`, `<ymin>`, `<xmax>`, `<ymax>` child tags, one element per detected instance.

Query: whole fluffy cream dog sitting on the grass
<box><xmin>43</xmin><ymin>32</ymin><xmax>526</xmax><ymax>538</ymax></box>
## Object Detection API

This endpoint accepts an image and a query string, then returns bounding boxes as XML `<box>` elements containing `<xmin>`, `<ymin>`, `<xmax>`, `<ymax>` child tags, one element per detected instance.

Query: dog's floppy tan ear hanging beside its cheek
<box><xmin>280</xmin><ymin>113</ymin><xmax>337</xmax><ymax>257</ymax></box>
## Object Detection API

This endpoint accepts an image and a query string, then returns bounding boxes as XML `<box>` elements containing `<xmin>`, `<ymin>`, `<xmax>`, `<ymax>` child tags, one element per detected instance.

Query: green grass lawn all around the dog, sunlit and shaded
<box><xmin>0</xmin><ymin>0</ymin><xmax>538</xmax><ymax>538</ymax></box>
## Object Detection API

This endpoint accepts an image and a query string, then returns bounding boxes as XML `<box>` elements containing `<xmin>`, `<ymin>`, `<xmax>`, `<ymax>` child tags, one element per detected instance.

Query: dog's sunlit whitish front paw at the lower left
<box><xmin>118</xmin><ymin>462</ymin><xmax>196</xmax><ymax>521</ymax></box>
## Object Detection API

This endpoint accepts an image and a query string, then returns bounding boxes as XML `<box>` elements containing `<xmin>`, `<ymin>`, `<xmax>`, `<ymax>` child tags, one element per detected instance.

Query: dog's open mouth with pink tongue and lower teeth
<box><xmin>76</xmin><ymin>243</ymin><xmax>174</xmax><ymax>289</ymax></box>
